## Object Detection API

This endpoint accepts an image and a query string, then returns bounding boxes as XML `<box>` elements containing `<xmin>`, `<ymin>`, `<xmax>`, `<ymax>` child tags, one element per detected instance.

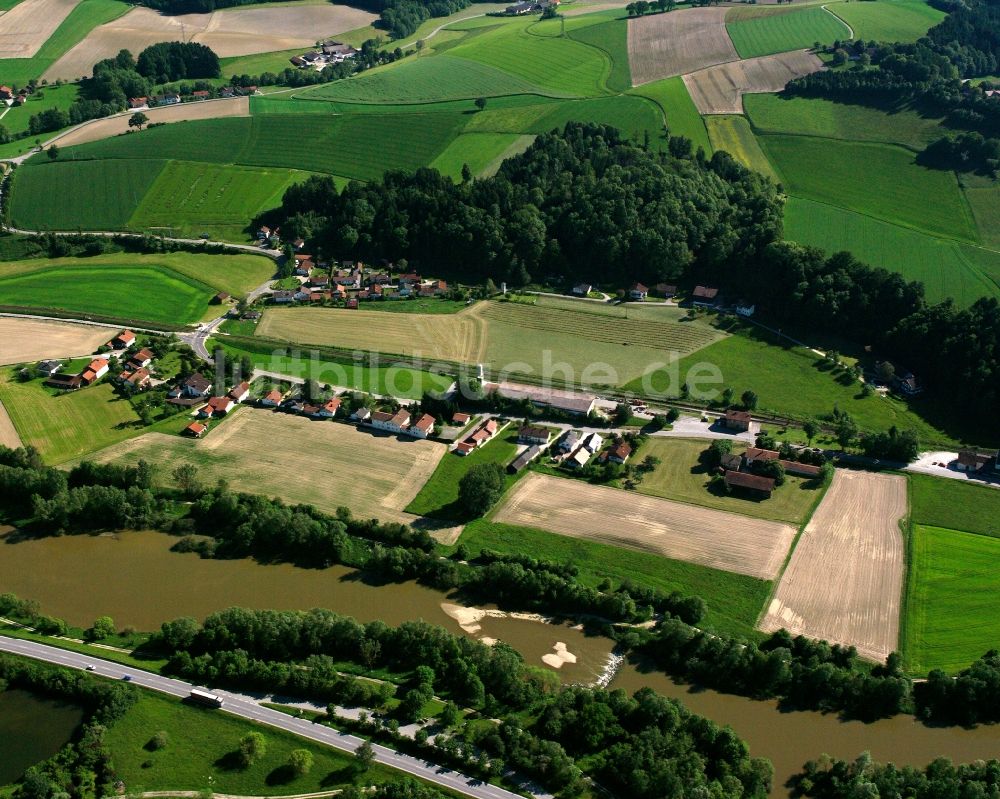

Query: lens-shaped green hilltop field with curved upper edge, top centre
<box><xmin>302</xmin><ymin>55</ymin><xmax>560</xmax><ymax>103</ymax></box>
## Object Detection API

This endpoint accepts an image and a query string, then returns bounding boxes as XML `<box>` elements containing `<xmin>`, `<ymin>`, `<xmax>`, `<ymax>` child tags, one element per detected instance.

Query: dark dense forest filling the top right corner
<box><xmin>785</xmin><ymin>0</ymin><xmax>1000</xmax><ymax>174</ymax></box>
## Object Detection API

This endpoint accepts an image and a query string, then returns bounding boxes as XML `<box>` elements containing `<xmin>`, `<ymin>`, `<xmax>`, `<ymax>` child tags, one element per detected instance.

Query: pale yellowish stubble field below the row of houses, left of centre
<box><xmin>92</xmin><ymin>407</ymin><xmax>447</xmax><ymax>524</ymax></box>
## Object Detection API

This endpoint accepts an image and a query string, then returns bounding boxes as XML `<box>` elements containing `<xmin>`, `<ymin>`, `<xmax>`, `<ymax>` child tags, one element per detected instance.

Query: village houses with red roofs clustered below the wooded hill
<box><xmin>271</xmin><ymin>252</ymin><xmax>448</xmax><ymax>308</ymax></box>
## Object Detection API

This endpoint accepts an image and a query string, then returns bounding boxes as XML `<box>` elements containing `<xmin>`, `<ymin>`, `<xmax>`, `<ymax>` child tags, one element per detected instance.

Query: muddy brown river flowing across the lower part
<box><xmin>0</xmin><ymin>533</ymin><xmax>1000</xmax><ymax>797</ymax></box>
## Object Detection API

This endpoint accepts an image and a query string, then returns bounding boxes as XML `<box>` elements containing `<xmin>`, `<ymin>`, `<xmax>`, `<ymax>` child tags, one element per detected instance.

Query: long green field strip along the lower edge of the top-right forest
<box><xmin>743</xmin><ymin>94</ymin><xmax>945</xmax><ymax>150</ymax></box>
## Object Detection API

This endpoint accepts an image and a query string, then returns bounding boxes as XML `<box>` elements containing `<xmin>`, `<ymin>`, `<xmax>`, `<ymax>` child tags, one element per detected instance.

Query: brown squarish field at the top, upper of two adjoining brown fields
<box><xmin>628</xmin><ymin>8</ymin><xmax>739</xmax><ymax>86</ymax></box>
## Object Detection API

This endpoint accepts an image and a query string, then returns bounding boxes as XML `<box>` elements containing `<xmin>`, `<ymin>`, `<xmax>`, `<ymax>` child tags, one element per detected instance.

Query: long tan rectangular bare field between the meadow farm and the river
<box><xmin>494</xmin><ymin>474</ymin><xmax>795</xmax><ymax>580</ymax></box>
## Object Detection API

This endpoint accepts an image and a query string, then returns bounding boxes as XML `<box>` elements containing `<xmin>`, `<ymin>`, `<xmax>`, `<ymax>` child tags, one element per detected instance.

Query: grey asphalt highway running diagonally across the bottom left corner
<box><xmin>0</xmin><ymin>636</ymin><xmax>540</xmax><ymax>799</ymax></box>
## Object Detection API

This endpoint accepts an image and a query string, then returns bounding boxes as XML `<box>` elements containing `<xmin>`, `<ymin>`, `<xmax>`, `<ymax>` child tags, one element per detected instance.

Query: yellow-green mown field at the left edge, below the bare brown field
<box><xmin>0</xmin><ymin>370</ymin><xmax>140</xmax><ymax>463</ymax></box>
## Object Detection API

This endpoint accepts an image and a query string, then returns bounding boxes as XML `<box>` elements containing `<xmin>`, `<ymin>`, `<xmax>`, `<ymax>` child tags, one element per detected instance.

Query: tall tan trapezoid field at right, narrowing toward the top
<box><xmin>759</xmin><ymin>469</ymin><xmax>907</xmax><ymax>662</ymax></box>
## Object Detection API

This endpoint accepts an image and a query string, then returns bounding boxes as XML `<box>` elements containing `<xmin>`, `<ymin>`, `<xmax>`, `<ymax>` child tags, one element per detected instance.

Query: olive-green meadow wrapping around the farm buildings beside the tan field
<box><xmin>632</xmin><ymin>438</ymin><xmax>823</xmax><ymax>525</ymax></box>
